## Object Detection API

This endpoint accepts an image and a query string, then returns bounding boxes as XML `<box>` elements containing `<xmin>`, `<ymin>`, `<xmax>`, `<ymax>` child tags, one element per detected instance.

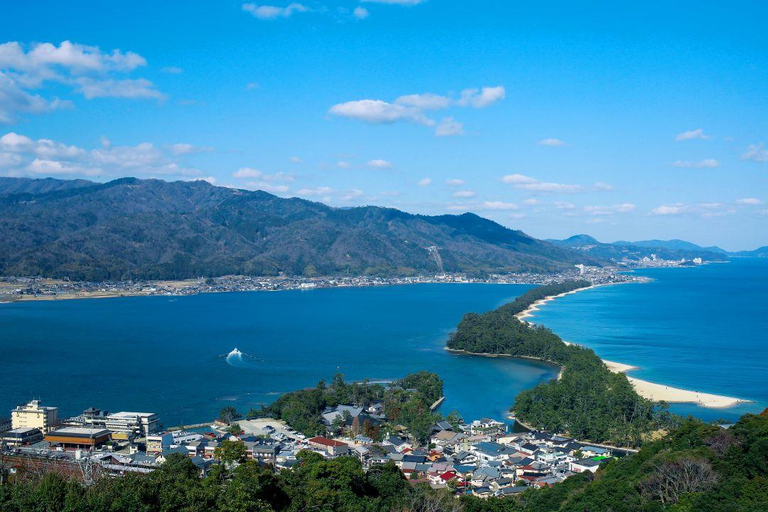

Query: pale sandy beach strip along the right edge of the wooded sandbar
<box><xmin>515</xmin><ymin>283</ymin><xmax>751</xmax><ymax>409</ymax></box>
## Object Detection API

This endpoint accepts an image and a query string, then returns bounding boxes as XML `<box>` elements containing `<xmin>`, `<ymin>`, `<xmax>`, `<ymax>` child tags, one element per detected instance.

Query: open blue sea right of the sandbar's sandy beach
<box><xmin>530</xmin><ymin>259</ymin><xmax>768</xmax><ymax>420</ymax></box>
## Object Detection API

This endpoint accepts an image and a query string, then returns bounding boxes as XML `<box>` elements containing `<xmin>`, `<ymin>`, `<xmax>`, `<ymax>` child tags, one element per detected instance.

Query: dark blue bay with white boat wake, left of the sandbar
<box><xmin>0</xmin><ymin>284</ymin><xmax>556</xmax><ymax>426</ymax></box>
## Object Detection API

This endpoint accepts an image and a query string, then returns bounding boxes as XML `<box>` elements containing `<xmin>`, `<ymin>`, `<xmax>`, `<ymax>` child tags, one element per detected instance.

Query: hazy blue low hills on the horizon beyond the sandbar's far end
<box><xmin>548</xmin><ymin>235</ymin><xmax>728</xmax><ymax>262</ymax></box>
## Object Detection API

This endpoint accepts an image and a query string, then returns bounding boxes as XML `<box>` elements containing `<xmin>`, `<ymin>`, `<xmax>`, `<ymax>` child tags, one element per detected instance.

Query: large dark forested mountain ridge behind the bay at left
<box><xmin>0</xmin><ymin>178</ymin><xmax>603</xmax><ymax>281</ymax></box>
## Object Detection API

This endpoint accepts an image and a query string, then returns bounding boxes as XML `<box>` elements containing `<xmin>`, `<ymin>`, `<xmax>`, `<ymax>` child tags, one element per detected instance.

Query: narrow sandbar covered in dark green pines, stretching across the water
<box><xmin>448</xmin><ymin>281</ymin><xmax>677</xmax><ymax>446</ymax></box>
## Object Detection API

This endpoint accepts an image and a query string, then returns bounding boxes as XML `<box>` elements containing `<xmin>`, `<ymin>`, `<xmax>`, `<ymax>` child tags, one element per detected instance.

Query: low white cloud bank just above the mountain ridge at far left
<box><xmin>0</xmin><ymin>132</ymin><xmax>201</xmax><ymax>176</ymax></box>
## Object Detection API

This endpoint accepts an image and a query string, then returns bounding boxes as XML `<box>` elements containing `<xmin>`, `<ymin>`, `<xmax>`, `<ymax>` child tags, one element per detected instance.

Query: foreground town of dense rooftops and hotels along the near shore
<box><xmin>0</xmin><ymin>400</ymin><xmax>632</xmax><ymax>497</ymax></box>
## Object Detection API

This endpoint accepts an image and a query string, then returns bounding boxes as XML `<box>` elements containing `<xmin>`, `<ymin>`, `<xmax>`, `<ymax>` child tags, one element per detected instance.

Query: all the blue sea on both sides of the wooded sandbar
<box><xmin>0</xmin><ymin>260</ymin><xmax>768</xmax><ymax>427</ymax></box>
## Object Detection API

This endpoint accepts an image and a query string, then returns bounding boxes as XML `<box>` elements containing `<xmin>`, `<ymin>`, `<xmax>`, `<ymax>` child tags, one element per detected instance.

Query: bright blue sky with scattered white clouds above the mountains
<box><xmin>0</xmin><ymin>0</ymin><xmax>768</xmax><ymax>250</ymax></box>
